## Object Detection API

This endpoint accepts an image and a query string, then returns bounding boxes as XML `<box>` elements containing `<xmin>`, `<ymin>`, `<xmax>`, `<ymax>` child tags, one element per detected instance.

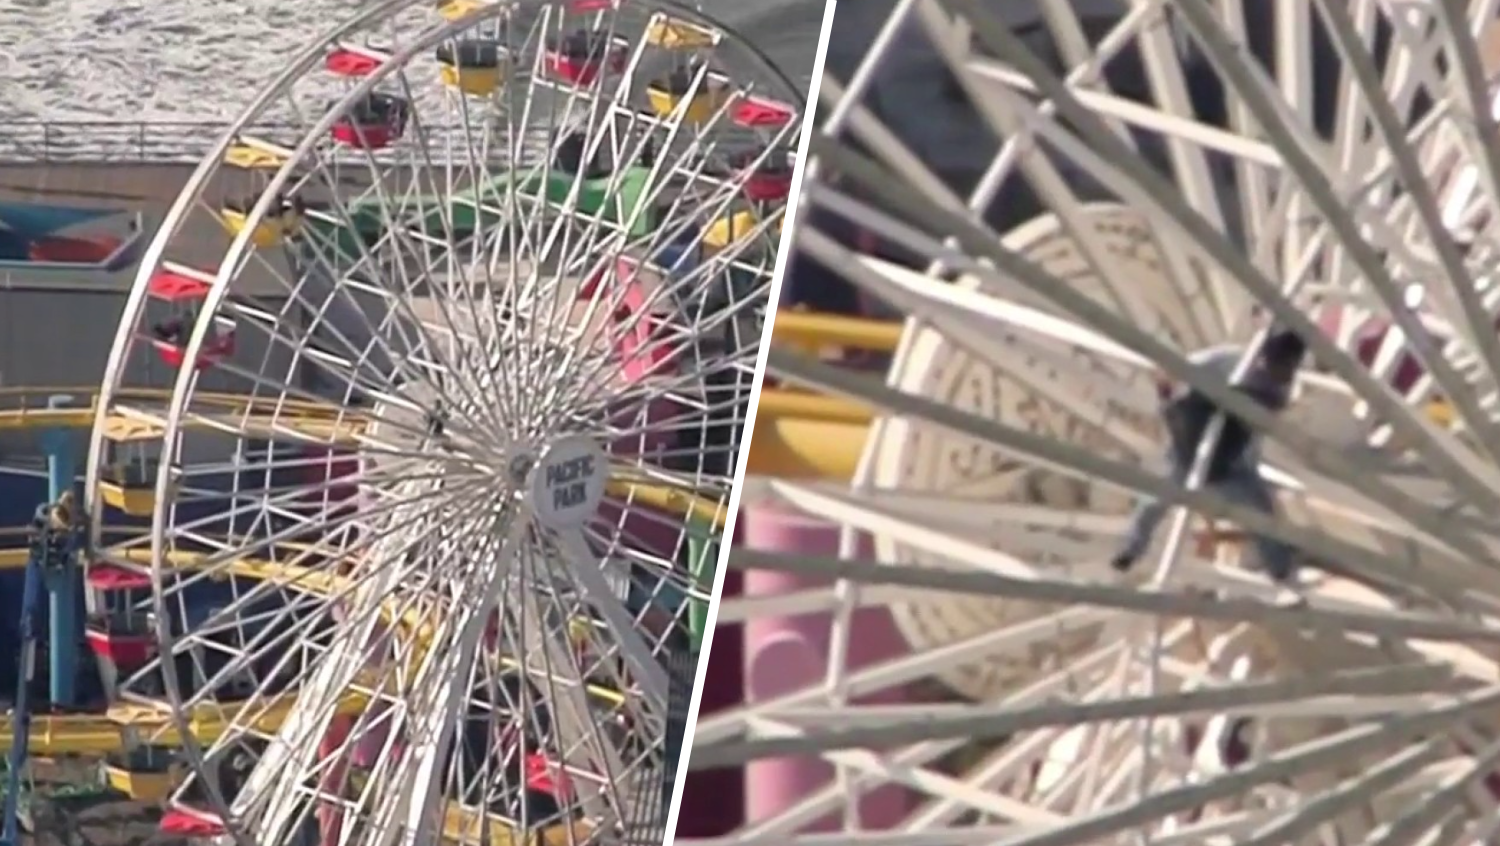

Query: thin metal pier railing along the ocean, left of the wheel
<box><xmin>0</xmin><ymin>120</ymin><xmax>300</xmax><ymax>165</ymax></box>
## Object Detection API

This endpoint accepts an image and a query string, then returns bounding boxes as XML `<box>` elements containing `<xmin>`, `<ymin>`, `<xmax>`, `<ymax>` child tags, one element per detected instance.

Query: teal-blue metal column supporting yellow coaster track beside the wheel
<box><xmin>42</xmin><ymin>395</ymin><xmax>83</xmax><ymax>708</ymax></box>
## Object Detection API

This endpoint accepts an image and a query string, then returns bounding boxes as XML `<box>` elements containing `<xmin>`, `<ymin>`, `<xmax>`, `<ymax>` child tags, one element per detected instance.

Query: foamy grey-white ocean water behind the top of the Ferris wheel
<box><xmin>0</xmin><ymin>0</ymin><xmax>824</xmax><ymax>146</ymax></box>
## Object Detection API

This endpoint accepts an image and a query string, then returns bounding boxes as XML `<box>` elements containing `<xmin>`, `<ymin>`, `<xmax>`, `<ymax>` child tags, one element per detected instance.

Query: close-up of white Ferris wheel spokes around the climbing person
<box><xmin>690</xmin><ymin>0</ymin><xmax>1500</xmax><ymax>846</ymax></box>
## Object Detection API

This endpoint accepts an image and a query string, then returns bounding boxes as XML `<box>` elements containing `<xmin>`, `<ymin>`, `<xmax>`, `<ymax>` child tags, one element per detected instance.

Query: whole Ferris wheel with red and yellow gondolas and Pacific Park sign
<box><xmin>74</xmin><ymin>0</ymin><xmax>803</xmax><ymax>845</ymax></box>
